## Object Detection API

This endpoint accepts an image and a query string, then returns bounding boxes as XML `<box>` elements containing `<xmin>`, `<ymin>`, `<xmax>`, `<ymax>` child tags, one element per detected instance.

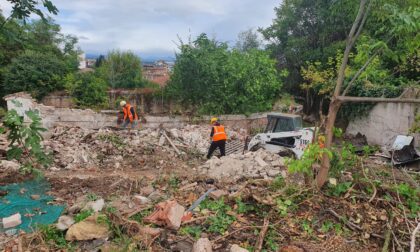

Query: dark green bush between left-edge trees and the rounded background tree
<box><xmin>64</xmin><ymin>73</ymin><xmax>108</xmax><ymax>108</ymax></box>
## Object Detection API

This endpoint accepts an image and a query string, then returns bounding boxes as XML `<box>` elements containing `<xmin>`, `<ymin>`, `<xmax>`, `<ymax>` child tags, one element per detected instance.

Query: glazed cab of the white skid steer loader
<box><xmin>265</xmin><ymin>113</ymin><xmax>302</xmax><ymax>133</ymax></box>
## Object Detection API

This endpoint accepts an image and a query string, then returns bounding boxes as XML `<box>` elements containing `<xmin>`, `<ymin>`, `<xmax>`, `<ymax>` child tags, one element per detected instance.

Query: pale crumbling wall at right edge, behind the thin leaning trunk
<box><xmin>346</xmin><ymin>103</ymin><xmax>420</xmax><ymax>146</ymax></box>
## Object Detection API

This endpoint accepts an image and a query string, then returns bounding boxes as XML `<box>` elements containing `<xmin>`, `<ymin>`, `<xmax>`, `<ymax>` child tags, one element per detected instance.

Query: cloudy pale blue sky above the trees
<box><xmin>0</xmin><ymin>0</ymin><xmax>281</xmax><ymax>58</ymax></box>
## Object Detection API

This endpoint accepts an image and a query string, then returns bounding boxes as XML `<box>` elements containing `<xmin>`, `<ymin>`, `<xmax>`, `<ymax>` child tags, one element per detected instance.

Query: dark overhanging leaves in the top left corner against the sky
<box><xmin>0</xmin><ymin>0</ymin><xmax>58</xmax><ymax>30</ymax></box>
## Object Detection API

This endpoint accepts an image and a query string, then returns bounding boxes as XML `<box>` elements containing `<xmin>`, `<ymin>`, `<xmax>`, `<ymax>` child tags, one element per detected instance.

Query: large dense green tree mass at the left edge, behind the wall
<box><xmin>0</xmin><ymin>17</ymin><xmax>80</xmax><ymax>98</ymax></box>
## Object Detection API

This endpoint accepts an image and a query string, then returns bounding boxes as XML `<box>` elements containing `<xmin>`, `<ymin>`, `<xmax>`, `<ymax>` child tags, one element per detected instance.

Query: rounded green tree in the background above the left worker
<box><xmin>98</xmin><ymin>51</ymin><xmax>143</xmax><ymax>88</ymax></box>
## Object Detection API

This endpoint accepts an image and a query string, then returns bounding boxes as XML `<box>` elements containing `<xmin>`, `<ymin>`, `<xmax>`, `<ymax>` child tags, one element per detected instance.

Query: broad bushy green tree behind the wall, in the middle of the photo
<box><xmin>166</xmin><ymin>34</ymin><xmax>281</xmax><ymax>114</ymax></box>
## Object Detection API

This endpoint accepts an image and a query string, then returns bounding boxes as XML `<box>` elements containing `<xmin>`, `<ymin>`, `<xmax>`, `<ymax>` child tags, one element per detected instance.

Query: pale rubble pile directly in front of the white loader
<box><xmin>199</xmin><ymin>149</ymin><xmax>287</xmax><ymax>180</ymax></box>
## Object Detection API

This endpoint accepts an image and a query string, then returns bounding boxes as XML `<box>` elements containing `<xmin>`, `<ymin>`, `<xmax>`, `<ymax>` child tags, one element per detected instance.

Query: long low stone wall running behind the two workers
<box><xmin>4</xmin><ymin>92</ymin><xmax>267</xmax><ymax>130</ymax></box>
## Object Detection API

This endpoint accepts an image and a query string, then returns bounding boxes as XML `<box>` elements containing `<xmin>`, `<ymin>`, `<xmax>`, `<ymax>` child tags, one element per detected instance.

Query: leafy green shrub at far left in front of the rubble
<box><xmin>3</xmin><ymin>105</ymin><xmax>51</xmax><ymax>173</ymax></box>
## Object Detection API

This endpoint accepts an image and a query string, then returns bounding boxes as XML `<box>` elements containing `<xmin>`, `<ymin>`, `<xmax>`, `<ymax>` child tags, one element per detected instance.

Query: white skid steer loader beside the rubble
<box><xmin>245</xmin><ymin>113</ymin><xmax>315</xmax><ymax>159</ymax></box>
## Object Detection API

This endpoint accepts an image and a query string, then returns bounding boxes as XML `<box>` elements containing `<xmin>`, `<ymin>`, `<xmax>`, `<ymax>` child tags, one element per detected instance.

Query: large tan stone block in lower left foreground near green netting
<box><xmin>66</xmin><ymin>214</ymin><xmax>110</xmax><ymax>241</ymax></box>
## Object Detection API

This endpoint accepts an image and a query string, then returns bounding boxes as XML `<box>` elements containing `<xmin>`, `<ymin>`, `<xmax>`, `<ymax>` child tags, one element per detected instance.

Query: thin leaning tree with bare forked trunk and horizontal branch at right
<box><xmin>316</xmin><ymin>0</ymin><xmax>420</xmax><ymax>187</ymax></box>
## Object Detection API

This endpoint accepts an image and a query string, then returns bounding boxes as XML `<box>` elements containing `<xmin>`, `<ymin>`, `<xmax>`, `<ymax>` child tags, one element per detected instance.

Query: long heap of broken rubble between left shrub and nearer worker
<box><xmin>43</xmin><ymin>125</ymin><xmax>246</xmax><ymax>170</ymax></box>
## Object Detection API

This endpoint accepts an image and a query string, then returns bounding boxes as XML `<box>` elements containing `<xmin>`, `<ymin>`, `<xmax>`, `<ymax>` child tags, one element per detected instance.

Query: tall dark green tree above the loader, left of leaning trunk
<box><xmin>260</xmin><ymin>0</ymin><xmax>357</xmax><ymax>95</ymax></box>
